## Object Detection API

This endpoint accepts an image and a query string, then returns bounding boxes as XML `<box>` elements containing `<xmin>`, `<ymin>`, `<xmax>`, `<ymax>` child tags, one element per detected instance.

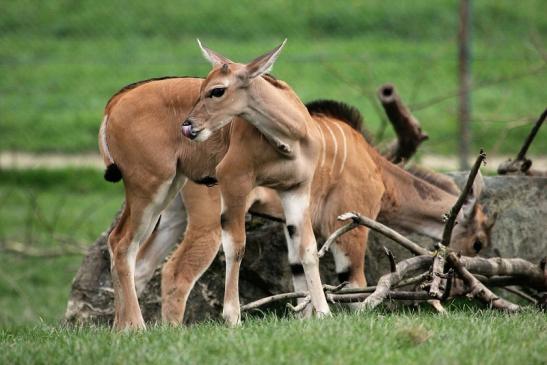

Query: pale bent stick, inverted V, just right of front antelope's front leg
<box><xmin>318</xmin><ymin>212</ymin><xmax>432</xmax><ymax>257</ymax></box>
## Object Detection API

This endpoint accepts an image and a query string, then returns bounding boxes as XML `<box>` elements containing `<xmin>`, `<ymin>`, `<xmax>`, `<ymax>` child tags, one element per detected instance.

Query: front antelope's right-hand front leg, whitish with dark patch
<box><xmin>281</xmin><ymin>191</ymin><xmax>330</xmax><ymax>317</ymax></box>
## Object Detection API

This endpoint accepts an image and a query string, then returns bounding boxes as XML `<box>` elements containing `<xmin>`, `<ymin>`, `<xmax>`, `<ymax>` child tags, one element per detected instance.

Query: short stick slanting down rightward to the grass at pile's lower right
<box><xmin>447</xmin><ymin>252</ymin><xmax>520</xmax><ymax>312</ymax></box>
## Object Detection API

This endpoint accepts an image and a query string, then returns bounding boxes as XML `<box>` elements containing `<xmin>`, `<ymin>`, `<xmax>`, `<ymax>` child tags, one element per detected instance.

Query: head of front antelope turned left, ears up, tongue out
<box><xmin>182</xmin><ymin>39</ymin><xmax>287</xmax><ymax>142</ymax></box>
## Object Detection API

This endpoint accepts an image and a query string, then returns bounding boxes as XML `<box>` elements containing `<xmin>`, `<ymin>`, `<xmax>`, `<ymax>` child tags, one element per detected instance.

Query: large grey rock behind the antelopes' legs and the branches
<box><xmin>65</xmin><ymin>173</ymin><xmax>547</xmax><ymax>323</ymax></box>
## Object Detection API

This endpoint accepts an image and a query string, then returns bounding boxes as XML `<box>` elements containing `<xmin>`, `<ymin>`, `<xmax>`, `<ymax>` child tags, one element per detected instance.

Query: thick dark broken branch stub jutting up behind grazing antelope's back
<box><xmin>378</xmin><ymin>84</ymin><xmax>429</xmax><ymax>163</ymax></box>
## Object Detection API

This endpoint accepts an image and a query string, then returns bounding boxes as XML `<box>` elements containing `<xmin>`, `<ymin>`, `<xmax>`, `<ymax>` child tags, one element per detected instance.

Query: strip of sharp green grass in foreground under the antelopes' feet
<box><xmin>0</xmin><ymin>308</ymin><xmax>547</xmax><ymax>365</ymax></box>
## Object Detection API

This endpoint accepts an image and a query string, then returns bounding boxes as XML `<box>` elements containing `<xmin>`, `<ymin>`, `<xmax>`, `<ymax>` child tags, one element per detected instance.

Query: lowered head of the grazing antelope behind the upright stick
<box><xmin>450</xmin><ymin>172</ymin><xmax>495</xmax><ymax>256</ymax></box>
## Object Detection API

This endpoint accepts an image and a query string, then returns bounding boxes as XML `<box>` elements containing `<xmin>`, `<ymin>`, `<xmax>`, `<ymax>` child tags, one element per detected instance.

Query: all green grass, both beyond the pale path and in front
<box><xmin>0</xmin><ymin>0</ymin><xmax>547</xmax><ymax>364</ymax></box>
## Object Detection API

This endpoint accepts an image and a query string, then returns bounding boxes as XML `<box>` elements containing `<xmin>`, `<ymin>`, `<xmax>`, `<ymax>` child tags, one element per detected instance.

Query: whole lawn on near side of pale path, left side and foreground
<box><xmin>0</xmin><ymin>170</ymin><xmax>547</xmax><ymax>364</ymax></box>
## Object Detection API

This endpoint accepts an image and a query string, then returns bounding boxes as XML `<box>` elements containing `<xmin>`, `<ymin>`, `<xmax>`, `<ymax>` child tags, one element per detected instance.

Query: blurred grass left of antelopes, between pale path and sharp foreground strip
<box><xmin>0</xmin><ymin>170</ymin><xmax>123</xmax><ymax>327</ymax></box>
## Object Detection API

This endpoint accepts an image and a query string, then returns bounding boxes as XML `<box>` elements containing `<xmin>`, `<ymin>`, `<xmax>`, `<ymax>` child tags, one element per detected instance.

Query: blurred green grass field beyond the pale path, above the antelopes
<box><xmin>0</xmin><ymin>0</ymin><xmax>547</xmax><ymax>155</ymax></box>
